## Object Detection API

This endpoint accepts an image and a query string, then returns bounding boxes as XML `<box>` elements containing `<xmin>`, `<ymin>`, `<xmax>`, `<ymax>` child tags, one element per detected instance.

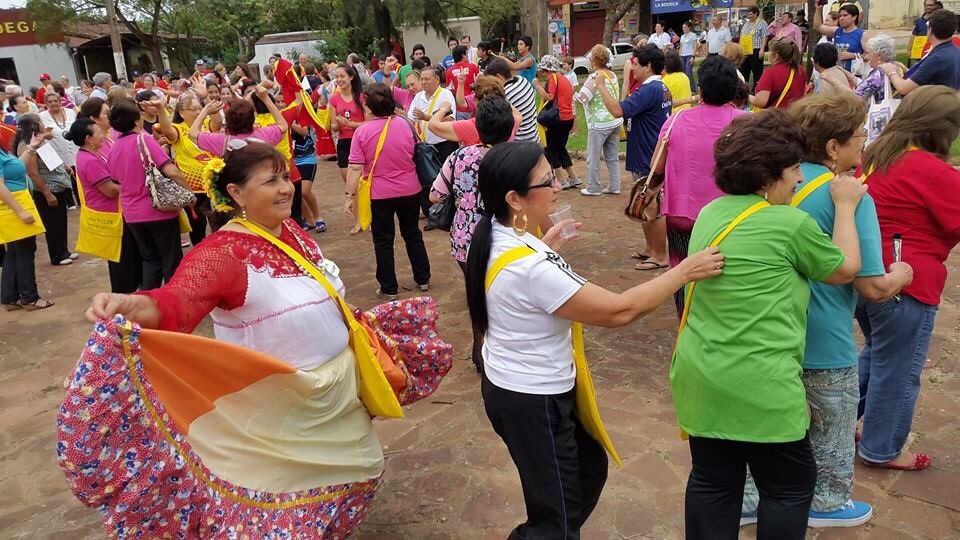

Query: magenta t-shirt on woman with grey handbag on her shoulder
<box><xmin>107</xmin><ymin>133</ymin><xmax>177</xmax><ymax>223</ymax></box>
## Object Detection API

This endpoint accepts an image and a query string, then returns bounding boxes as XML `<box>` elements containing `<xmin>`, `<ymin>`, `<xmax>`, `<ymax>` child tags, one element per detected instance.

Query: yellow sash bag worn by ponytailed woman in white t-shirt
<box><xmin>485</xmin><ymin>246</ymin><xmax>623</xmax><ymax>467</ymax></box>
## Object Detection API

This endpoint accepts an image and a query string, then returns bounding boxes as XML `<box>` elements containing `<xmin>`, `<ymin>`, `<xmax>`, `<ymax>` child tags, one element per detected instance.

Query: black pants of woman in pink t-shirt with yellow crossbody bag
<box><xmin>370</xmin><ymin>194</ymin><xmax>430</xmax><ymax>294</ymax></box>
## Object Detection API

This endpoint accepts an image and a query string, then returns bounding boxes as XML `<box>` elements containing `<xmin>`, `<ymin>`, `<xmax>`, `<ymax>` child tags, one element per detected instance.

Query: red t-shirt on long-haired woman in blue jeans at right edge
<box><xmin>867</xmin><ymin>150</ymin><xmax>960</xmax><ymax>306</ymax></box>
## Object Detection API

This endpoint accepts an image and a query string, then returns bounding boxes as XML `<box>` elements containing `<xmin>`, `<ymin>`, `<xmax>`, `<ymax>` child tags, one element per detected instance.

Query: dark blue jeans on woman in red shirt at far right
<box><xmin>856</xmin><ymin>294</ymin><xmax>937</xmax><ymax>463</ymax></box>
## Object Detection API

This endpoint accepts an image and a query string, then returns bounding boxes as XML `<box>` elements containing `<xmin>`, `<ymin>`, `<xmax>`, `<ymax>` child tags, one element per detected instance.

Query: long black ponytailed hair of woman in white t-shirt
<box><xmin>467</xmin><ymin>139</ymin><xmax>543</xmax><ymax>332</ymax></box>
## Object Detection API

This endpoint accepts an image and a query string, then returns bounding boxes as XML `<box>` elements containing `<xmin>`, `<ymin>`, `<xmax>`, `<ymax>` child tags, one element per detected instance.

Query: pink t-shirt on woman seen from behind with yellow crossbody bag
<box><xmin>350</xmin><ymin>116</ymin><xmax>421</xmax><ymax>199</ymax></box>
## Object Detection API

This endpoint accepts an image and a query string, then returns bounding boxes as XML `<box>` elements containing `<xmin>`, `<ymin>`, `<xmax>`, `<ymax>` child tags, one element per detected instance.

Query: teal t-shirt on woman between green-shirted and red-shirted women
<box><xmin>797</xmin><ymin>163</ymin><xmax>885</xmax><ymax>369</ymax></box>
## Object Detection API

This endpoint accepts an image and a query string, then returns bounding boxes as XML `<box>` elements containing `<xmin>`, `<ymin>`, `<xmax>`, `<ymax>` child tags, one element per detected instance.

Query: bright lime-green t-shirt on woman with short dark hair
<box><xmin>670</xmin><ymin>195</ymin><xmax>843</xmax><ymax>442</ymax></box>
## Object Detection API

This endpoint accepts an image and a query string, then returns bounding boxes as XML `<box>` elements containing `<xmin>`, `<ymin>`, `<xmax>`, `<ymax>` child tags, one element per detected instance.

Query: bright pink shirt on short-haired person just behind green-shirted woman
<box><xmin>660</xmin><ymin>104</ymin><xmax>749</xmax><ymax>221</ymax></box>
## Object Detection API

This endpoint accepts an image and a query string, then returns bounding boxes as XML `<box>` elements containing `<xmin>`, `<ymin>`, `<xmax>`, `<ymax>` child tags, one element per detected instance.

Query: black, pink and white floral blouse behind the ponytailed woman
<box><xmin>430</xmin><ymin>144</ymin><xmax>488</xmax><ymax>262</ymax></box>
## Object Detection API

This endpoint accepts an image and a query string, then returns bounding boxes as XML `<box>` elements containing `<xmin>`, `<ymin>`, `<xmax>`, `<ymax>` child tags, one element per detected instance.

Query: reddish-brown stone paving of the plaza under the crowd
<box><xmin>0</xmin><ymin>162</ymin><xmax>960</xmax><ymax>540</ymax></box>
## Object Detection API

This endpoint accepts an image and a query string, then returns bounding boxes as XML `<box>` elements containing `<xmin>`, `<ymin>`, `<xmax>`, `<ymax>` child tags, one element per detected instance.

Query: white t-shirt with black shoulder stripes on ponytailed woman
<box><xmin>483</xmin><ymin>220</ymin><xmax>587</xmax><ymax>395</ymax></box>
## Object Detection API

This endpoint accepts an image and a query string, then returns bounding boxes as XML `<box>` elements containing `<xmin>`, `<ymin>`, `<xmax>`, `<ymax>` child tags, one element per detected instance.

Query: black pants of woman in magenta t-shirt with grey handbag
<box><xmin>129</xmin><ymin>218</ymin><xmax>183</xmax><ymax>291</ymax></box>
